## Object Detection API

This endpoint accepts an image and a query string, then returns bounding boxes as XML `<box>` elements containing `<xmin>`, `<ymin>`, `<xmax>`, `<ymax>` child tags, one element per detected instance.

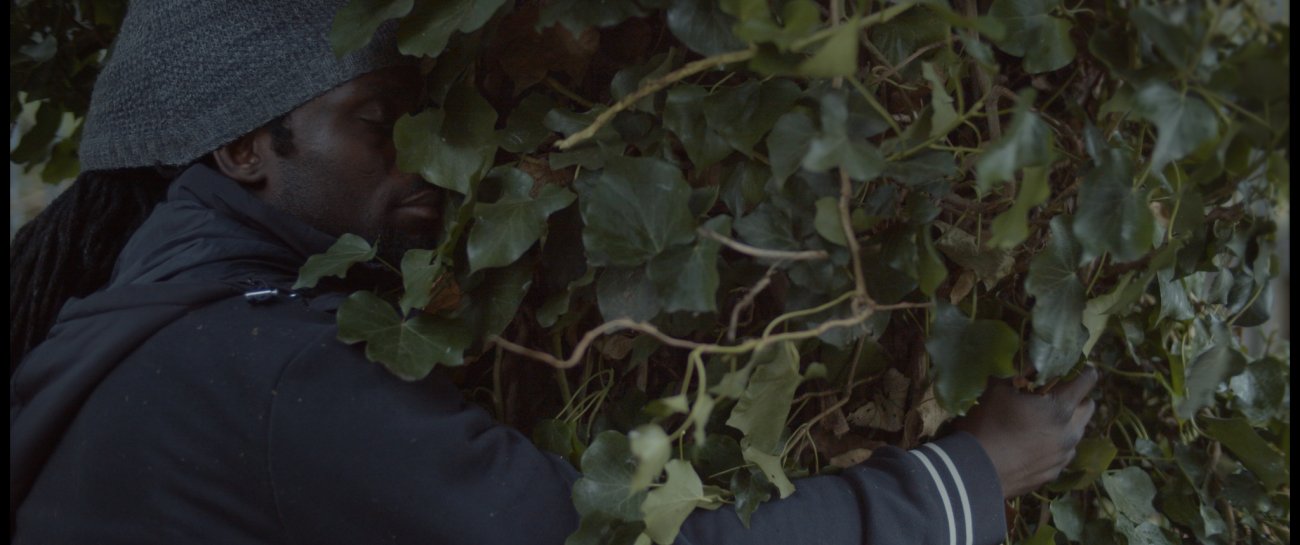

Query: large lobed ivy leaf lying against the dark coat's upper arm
<box><xmin>338</xmin><ymin>291</ymin><xmax>473</xmax><ymax>381</ymax></box>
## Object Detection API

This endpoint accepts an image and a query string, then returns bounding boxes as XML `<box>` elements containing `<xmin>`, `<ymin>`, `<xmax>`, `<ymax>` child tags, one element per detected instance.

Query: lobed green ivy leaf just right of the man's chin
<box><xmin>467</xmin><ymin>166</ymin><xmax>575</xmax><ymax>272</ymax></box>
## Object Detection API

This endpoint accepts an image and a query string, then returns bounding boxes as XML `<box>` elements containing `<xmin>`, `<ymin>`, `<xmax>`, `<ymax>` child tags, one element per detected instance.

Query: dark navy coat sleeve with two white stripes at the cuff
<box><xmin>268</xmin><ymin>333</ymin><xmax>1004</xmax><ymax>545</ymax></box>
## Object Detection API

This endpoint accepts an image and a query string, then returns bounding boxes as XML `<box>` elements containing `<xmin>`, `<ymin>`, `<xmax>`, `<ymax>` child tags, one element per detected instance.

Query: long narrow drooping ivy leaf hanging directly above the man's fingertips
<box><xmin>1024</xmin><ymin>216</ymin><xmax>1087</xmax><ymax>384</ymax></box>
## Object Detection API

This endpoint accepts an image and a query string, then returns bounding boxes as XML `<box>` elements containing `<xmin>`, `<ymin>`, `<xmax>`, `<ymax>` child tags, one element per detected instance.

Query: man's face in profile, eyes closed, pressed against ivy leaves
<box><xmin>255</xmin><ymin>66</ymin><xmax>442</xmax><ymax>260</ymax></box>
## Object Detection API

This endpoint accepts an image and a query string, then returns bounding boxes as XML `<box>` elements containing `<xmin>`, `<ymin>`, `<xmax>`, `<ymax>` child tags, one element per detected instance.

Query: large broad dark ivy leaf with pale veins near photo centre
<box><xmin>577</xmin><ymin>157</ymin><xmax>696</xmax><ymax>267</ymax></box>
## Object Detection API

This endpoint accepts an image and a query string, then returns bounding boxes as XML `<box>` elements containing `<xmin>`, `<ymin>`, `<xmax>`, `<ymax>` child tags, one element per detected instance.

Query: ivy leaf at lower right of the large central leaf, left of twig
<box><xmin>646</xmin><ymin>216</ymin><xmax>731</xmax><ymax>312</ymax></box>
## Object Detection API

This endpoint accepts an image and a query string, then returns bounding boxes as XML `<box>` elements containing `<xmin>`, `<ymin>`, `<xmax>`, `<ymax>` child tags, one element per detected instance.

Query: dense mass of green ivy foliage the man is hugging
<box><xmin>10</xmin><ymin>0</ymin><xmax>1290</xmax><ymax>544</ymax></box>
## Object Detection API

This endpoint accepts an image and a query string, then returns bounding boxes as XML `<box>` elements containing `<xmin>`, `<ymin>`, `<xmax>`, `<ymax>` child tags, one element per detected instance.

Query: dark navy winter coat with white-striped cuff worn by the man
<box><xmin>9</xmin><ymin>166</ymin><xmax>1005</xmax><ymax>545</ymax></box>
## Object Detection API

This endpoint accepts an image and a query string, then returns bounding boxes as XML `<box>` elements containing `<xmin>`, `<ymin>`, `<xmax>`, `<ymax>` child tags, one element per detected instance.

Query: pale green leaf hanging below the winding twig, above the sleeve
<box><xmin>727</xmin><ymin>342</ymin><xmax>801</xmax><ymax>459</ymax></box>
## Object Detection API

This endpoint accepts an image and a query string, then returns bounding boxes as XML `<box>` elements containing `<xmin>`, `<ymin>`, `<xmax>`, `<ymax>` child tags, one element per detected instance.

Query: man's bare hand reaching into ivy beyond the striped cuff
<box><xmin>954</xmin><ymin>368</ymin><xmax>1097</xmax><ymax>498</ymax></box>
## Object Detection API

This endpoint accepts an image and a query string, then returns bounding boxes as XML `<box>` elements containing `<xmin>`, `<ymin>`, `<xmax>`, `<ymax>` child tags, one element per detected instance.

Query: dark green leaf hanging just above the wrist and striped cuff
<box><xmin>926</xmin><ymin>300</ymin><xmax>1021</xmax><ymax>415</ymax></box>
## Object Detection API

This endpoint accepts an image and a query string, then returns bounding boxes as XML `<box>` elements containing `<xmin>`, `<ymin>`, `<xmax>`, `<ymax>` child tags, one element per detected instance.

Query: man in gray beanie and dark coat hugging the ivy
<box><xmin>9</xmin><ymin>1</ymin><xmax>1095</xmax><ymax>544</ymax></box>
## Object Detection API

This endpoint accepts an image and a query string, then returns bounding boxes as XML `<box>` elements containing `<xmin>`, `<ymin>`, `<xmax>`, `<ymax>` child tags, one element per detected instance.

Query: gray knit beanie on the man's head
<box><xmin>79</xmin><ymin>0</ymin><xmax>413</xmax><ymax>170</ymax></box>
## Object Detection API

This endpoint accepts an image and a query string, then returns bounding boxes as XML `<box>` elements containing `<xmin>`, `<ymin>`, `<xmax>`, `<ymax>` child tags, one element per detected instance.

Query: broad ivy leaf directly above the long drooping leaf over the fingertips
<box><xmin>1074</xmin><ymin>148</ymin><xmax>1154</xmax><ymax>261</ymax></box>
